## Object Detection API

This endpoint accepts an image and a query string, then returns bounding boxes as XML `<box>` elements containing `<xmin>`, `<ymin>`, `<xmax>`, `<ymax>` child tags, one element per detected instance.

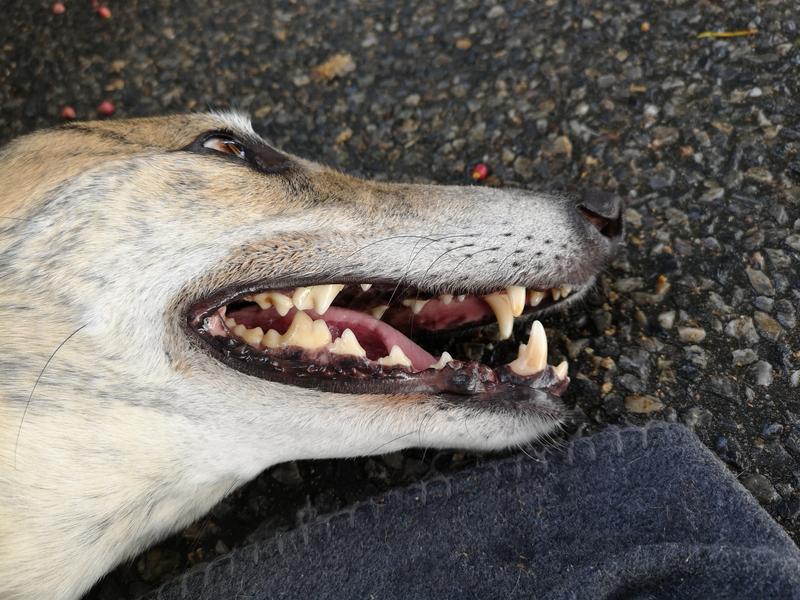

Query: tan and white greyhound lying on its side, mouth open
<box><xmin>0</xmin><ymin>112</ymin><xmax>622</xmax><ymax>600</ymax></box>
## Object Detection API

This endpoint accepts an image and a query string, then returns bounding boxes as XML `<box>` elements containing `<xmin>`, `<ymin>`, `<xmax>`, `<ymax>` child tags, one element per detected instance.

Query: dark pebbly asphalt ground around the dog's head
<box><xmin>0</xmin><ymin>0</ymin><xmax>800</xmax><ymax>600</ymax></box>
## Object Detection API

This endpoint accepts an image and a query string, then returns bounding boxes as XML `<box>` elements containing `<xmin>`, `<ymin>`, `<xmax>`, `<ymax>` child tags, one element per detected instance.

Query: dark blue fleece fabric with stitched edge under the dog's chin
<box><xmin>142</xmin><ymin>425</ymin><xmax>800</xmax><ymax>600</ymax></box>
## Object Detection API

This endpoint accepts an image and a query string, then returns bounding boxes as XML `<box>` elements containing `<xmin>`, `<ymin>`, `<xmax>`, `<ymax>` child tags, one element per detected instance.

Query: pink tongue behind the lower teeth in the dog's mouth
<box><xmin>308</xmin><ymin>306</ymin><xmax>436</xmax><ymax>371</ymax></box>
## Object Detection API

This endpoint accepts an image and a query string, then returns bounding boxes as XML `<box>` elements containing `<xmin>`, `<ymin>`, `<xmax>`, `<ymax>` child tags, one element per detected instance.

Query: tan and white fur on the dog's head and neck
<box><xmin>0</xmin><ymin>113</ymin><xmax>607</xmax><ymax>600</ymax></box>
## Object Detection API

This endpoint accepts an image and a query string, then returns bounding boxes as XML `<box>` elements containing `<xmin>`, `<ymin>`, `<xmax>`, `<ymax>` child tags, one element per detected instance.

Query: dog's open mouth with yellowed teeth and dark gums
<box><xmin>189</xmin><ymin>282</ymin><xmax>588</xmax><ymax>401</ymax></box>
